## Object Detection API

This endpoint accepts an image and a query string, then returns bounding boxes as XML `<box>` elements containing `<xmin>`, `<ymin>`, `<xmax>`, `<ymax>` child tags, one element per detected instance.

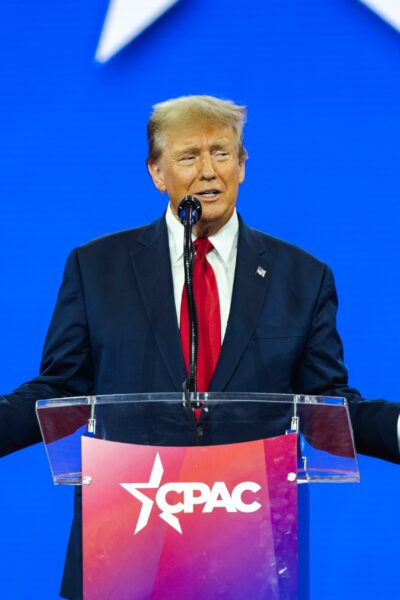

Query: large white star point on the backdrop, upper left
<box><xmin>95</xmin><ymin>0</ymin><xmax>178</xmax><ymax>63</ymax></box>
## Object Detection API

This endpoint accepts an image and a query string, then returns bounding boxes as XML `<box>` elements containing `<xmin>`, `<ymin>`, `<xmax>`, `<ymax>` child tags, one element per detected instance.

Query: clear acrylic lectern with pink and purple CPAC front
<box><xmin>37</xmin><ymin>393</ymin><xmax>359</xmax><ymax>600</ymax></box>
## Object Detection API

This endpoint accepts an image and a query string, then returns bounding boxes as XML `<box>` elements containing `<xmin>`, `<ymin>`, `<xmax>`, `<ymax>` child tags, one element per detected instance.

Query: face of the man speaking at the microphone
<box><xmin>149</xmin><ymin>124</ymin><xmax>245</xmax><ymax>236</ymax></box>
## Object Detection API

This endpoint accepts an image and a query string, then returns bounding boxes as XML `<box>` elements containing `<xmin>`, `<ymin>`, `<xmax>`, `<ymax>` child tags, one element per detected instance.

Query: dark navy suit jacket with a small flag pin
<box><xmin>0</xmin><ymin>213</ymin><xmax>400</xmax><ymax>598</ymax></box>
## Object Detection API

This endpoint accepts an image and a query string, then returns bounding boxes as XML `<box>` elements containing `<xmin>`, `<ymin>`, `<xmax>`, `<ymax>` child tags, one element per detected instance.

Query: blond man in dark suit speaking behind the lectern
<box><xmin>0</xmin><ymin>96</ymin><xmax>400</xmax><ymax>598</ymax></box>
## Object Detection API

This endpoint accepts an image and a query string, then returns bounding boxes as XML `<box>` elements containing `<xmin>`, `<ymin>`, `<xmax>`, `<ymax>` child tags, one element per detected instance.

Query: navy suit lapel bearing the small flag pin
<box><xmin>210</xmin><ymin>220</ymin><xmax>272</xmax><ymax>392</ymax></box>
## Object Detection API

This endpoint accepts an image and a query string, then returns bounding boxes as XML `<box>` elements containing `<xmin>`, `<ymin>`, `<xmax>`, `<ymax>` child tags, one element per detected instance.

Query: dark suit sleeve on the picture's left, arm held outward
<box><xmin>0</xmin><ymin>251</ymin><xmax>93</xmax><ymax>455</ymax></box>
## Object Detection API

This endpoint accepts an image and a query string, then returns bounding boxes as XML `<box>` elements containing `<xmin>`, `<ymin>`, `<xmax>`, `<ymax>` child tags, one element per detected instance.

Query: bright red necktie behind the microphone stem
<box><xmin>181</xmin><ymin>238</ymin><xmax>221</xmax><ymax>392</ymax></box>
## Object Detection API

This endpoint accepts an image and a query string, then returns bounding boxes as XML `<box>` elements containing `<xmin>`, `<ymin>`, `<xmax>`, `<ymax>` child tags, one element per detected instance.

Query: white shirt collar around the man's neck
<box><xmin>165</xmin><ymin>205</ymin><xmax>239</xmax><ymax>264</ymax></box>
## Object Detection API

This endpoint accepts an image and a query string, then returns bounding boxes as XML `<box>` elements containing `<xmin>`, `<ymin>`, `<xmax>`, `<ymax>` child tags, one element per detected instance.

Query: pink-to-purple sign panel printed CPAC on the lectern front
<box><xmin>83</xmin><ymin>435</ymin><xmax>297</xmax><ymax>600</ymax></box>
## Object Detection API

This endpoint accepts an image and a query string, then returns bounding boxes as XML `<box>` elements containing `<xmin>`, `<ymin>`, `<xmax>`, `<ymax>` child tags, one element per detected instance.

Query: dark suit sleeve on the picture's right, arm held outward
<box><xmin>295</xmin><ymin>267</ymin><xmax>400</xmax><ymax>464</ymax></box>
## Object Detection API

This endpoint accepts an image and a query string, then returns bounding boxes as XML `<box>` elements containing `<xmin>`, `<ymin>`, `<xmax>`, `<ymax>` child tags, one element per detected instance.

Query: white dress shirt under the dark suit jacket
<box><xmin>166</xmin><ymin>206</ymin><xmax>239</xmax><ymax>343</ymax></box>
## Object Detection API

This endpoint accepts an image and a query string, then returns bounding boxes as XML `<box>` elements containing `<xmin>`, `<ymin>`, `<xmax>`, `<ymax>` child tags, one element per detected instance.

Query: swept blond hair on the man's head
<box><xmin>147</xmin><ymin>96</ymin><xmax>247</xmax><ymax>164</ymax></box>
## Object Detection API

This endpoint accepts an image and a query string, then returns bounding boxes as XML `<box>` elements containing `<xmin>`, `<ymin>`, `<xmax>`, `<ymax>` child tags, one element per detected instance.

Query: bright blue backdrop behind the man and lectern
<box><xmin>0</xmin><ymin>0</ymin><xmax>400</xmax><ymax>600</ymax></box>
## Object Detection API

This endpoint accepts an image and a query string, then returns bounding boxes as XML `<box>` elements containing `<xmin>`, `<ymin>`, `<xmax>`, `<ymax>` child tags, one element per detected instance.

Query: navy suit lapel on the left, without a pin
<box><xmin>130</xmin><ymin>216</ymin><xmax>186</xmax><ymax>391</ymax></box>
